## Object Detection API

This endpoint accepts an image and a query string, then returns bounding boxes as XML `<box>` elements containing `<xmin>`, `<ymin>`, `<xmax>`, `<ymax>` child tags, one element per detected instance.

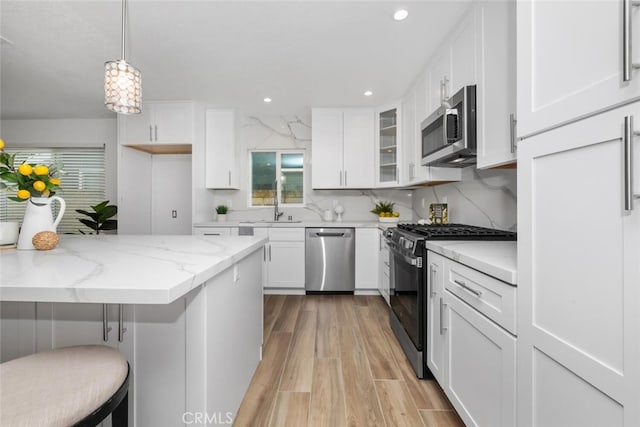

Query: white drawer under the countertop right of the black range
<box><xmin>444</xmin><ymin>260</ymin><xmax>517</xmax><ymax>335</ymax></box>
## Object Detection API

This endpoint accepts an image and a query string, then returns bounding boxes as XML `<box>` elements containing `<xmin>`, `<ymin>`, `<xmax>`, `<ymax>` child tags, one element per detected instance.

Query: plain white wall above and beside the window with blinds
<box><xmin>0</xmin><ymin>117</ymin><xmax>117</xmax><ymax>202</ymax></box>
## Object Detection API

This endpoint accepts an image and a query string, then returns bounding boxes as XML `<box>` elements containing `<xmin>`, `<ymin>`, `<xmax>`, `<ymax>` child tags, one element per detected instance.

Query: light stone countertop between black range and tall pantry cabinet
<box><xmin>426</xmin><ymin>240</ymin><xmax>518</xmax><ymax>285</ymax></box>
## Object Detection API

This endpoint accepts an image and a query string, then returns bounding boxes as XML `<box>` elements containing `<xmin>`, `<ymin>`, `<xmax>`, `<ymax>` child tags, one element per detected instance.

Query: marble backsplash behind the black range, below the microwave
<box><xmin>413</xmin><ymin>168</ymin><xmax>517</xmax><ymax>231</ymax></box>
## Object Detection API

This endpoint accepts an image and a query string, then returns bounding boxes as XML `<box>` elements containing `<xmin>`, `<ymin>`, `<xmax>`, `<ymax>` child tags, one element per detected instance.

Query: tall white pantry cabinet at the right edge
<box><xmin>517</xmin><ymin>0</ymin><xmax>640</xmax><ymax>427</ymax></box>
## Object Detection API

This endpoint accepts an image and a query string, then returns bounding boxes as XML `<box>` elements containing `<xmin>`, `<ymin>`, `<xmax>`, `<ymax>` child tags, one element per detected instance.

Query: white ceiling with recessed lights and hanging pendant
<box><xmin>0</xmin><ymin>0</ymin><xmax>468</xmax><ymax>119</ymax></box>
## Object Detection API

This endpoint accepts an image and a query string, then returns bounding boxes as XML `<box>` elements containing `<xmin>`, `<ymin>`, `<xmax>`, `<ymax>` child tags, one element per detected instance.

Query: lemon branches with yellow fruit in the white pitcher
<box><xmin>0</xmin><ymin>139</ymin><xmax>60</xmax><ymax>202</ymax></box>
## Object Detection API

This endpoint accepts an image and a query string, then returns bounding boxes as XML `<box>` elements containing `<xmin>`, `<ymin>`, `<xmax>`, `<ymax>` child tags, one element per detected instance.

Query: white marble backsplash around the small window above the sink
<box><xmin>193</xmin><ymin>112</ymin><xmax>413</xmax><ymax>222</ymax></box>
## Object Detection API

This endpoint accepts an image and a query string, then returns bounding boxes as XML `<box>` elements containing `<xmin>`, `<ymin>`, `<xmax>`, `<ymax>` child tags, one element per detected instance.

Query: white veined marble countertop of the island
<box><xmin>0</xmin><ymin>235</ymin><xmax>267</xmax><ymax>304</ymax></box>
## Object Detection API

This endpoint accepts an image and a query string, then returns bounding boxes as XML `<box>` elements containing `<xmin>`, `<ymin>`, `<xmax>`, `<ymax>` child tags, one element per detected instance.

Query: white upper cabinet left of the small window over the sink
<box><xmin>205</xmin><ymin>110</ymin><xmax>240</xmax><ymax>189</ymax></box>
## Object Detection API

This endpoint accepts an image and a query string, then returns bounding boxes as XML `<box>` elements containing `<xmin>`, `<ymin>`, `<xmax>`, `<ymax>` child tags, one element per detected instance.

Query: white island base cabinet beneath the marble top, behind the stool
<box><xmin>0</xmin><ymin>251</ymin><xmax>263</xmax><ymax>427</ymax></box>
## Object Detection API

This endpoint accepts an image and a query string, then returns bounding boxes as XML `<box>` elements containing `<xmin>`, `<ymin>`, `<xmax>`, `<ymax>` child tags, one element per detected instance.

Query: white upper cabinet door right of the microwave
<box><xmin>476</xmin><ymin>1</ymin><xmax>516</xmax><ymax>169</ymax></box>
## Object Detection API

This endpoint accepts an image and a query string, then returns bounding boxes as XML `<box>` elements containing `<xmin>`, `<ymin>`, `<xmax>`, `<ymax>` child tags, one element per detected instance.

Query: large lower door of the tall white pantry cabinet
<box><xmin>517</xmin><ymin>103</ymin><xmax>640</xmax><ymax>426</ymax></box>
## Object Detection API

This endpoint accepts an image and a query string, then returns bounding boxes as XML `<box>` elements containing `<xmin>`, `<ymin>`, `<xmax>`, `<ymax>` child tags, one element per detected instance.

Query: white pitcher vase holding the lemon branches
<box><xmin>18</xmin><ymin>196</ymin><xmax>66</xmax><ymax>249</ymax></box>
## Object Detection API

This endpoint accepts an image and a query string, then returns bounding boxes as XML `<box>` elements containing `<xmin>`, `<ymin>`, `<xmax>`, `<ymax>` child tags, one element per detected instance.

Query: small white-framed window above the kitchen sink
<box><xmin>250</xmin><ymin>151</ymin><xmax>304</xmax><ymax>206</ymax></box>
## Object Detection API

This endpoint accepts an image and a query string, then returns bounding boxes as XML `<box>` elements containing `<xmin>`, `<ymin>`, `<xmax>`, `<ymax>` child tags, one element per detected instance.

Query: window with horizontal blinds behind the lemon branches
<box><xmin>0</xmin><ymin>147</ymin><xmax>105</xmax><ymax>234</ymax></box>
